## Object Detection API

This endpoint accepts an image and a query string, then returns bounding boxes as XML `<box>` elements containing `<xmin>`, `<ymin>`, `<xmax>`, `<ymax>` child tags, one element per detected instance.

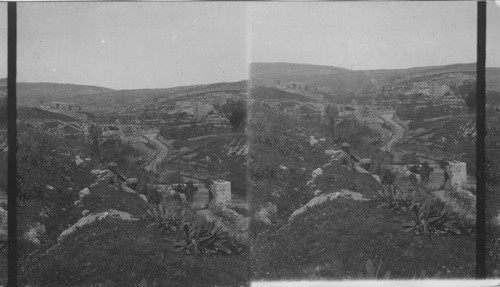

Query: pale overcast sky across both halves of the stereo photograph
<box><xmin>0</xmin><ymin>1</ymin><xmax>500</xmax><ymax>89</ymax></box>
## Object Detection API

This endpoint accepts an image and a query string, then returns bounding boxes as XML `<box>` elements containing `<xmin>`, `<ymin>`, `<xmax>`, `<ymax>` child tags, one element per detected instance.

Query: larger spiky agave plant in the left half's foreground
<box><xmin>173</xmin><ymin>217</ymin><xmax>231</xmax><ymax>255</ymax></box>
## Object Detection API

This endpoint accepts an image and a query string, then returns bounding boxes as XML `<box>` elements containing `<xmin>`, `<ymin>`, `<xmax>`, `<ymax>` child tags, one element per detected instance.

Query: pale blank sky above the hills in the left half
<box><xmin>18</xmin><ymin>2</ymin><xmax>248</xmax><ymax>89</ymax></box>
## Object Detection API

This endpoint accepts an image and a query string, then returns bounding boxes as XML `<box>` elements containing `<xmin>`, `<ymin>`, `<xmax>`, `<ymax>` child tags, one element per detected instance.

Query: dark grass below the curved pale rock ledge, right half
<box><xmin>252</xmin><ymin>199</ymin><xmax>475</xmax><ymax>280</ymax></box>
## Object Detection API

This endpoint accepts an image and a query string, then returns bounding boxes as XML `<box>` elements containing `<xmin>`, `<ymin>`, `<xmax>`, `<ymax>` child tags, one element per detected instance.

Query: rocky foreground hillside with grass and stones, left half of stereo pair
<box><xmin>18</xmin><ymin>124</ymin><xmax>249</xmax><ymax>286</ymax></box>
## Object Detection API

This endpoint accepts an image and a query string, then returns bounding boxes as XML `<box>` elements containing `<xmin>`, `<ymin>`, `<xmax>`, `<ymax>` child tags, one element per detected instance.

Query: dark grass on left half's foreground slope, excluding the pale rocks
<box><xmin>17</xmin><ymin>127</ymin><xmax>250</xmax><ymax>286</ymax></box>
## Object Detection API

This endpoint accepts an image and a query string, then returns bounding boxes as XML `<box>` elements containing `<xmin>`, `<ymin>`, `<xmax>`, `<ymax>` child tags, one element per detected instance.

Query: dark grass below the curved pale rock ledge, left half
<box><xmin>24</xmin><ymin>219</ymin><xmax>249</xmax><ymax>286</ymax></box>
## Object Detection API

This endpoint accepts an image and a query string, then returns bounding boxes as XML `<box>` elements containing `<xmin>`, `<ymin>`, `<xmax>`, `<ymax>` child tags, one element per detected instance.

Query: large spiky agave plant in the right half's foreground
<box><xmin>403</xmin><ymin>198</ymin><xmax>461</xmax><ymax>235</ymax></box>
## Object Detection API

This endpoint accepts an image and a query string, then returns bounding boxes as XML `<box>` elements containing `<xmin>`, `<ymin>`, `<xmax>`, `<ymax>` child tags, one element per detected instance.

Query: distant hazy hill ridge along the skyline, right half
<box><xmin>250</xmin><ymin>63</ymin><xmax>500</xmax><ymax>98</ymax></box>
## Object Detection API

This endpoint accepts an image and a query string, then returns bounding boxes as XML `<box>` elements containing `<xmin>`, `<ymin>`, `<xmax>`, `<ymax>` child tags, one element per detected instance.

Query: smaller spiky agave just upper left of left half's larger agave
<box><xmin>147</xmin><ymin>202</ymin><xmax>182</xmax><ymax>231</ymax></box>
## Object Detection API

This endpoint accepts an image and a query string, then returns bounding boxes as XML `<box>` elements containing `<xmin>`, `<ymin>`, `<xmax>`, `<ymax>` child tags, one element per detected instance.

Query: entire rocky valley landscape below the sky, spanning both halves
<box><xmin>3</xmin><ymin>60</ymin><xmax>495</xmax><ymax>286</ymax></box>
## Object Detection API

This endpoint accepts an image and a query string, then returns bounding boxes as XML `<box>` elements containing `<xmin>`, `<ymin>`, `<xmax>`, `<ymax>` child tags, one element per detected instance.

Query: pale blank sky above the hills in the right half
<box><xmin>249</xmin><ymin>1</ymin><xmax>492</xmax><ymax>70</ymax></box>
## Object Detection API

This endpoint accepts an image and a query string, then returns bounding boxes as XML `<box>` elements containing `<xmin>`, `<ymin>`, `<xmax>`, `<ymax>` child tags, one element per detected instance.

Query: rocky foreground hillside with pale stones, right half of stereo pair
<box><xmin>248</xmin><ymin>102</ymin><xmax>475</xmax><ymax>280</ymax></box>
